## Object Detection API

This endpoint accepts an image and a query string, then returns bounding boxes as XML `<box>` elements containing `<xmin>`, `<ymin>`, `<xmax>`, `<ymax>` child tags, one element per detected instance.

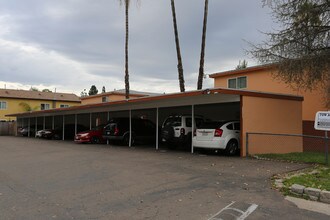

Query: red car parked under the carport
<box><xmin>74</xmin><ymin>125</ymin><xmax>105</xmax><ymax>144</ymax></box>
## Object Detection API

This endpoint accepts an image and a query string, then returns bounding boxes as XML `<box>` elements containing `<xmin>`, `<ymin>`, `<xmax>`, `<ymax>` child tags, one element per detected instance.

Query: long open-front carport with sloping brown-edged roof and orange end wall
<box><xmin>10</xmin><ymin>88</ymin><xmax>303</xmax><ymax>156</ymax></box>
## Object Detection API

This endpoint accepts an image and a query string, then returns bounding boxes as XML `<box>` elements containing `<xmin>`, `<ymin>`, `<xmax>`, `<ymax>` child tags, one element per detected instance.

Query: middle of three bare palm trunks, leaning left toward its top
<box><xmin>171</xmin><ymin>0</ymin><xmax>185</xmax><ymax>92</ymax></box>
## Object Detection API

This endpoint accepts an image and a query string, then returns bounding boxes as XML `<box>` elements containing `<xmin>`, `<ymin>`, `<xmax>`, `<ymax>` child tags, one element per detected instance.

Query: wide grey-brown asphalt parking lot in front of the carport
<box><xmin>0</xmin><ymin>137</ymin><xmax>329</xmax><ymax>220</ymax></box>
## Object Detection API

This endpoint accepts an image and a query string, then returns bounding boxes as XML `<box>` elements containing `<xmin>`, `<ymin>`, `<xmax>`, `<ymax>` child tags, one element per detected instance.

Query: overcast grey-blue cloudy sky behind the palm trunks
<box><xmin>0</xmin><ymin>0</ymin><xmax>274</xmax><ymax>95</ymax></box>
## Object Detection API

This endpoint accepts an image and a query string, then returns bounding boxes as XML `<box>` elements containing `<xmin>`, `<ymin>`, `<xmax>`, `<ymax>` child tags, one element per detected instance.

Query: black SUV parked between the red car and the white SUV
<box><xmin>102</xmin><ymin>117</ymin><xmax>156</xmax><ymax>146</ymax></box>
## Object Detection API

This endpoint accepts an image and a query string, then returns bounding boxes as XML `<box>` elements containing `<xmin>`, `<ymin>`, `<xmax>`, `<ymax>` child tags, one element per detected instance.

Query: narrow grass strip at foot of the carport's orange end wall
<box><xmin>257</xmin><ymin>152</ymin><xmax>330</xmax><ymax>164</ymax></box>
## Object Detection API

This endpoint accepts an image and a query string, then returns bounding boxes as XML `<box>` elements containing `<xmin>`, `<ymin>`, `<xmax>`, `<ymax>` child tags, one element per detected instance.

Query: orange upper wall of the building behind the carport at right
<box><xmin>214</xmin><ymin>70</ymin><xmax>327</xmax><ymax>121</ymax></box>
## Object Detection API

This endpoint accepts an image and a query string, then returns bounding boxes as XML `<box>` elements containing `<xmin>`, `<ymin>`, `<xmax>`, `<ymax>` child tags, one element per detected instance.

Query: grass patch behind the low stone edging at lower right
<box><xmin>283</xmin><ymin>167</ymin><xmax>330</xmax><ymax>191</ymax></box>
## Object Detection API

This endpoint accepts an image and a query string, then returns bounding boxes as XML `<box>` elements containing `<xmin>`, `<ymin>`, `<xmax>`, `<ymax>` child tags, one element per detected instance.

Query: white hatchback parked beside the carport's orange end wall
<box><xmin>193</xmin><ymin>121</ymin><xmax>240</xmax><ymax>155</ymax></box>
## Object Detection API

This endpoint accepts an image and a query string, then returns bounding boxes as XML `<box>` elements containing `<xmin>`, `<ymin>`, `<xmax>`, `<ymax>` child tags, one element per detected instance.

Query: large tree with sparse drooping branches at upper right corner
<box><xmin>250</xmin><ymin>0</ymin><xmax>330</xmax><ymax>107</ymax></box>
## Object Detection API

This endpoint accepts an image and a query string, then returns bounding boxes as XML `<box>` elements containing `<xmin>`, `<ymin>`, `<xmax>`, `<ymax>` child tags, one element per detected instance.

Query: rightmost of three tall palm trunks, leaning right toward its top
<box><xmin>197</xmin><ymin>0</ymin><xmax>209</xmax><ymax>90</ymax></box>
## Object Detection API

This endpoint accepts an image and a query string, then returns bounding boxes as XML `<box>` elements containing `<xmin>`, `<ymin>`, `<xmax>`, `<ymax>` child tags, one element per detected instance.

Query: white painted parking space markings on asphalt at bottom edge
<box><xmin>208</xmin><ymin>202</ymin><xmax>258</xmax><ymax>220</ymax></box>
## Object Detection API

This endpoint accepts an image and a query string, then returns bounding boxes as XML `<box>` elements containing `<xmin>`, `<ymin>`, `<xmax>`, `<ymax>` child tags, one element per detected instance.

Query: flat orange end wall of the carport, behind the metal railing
<box><xmin>241</xmin><ymin>96</ymin><xmax>303</xmax><ymax>156</ymax></box>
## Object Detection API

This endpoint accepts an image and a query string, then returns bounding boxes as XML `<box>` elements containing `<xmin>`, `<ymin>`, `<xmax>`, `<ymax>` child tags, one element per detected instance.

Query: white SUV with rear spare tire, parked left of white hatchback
<box><xmin>161</xmin><ymin>115</ymin><xmax>204</xmax><ymax>148</ymax></box>
